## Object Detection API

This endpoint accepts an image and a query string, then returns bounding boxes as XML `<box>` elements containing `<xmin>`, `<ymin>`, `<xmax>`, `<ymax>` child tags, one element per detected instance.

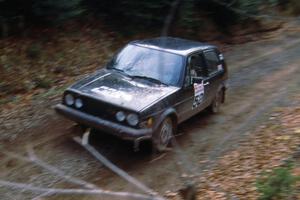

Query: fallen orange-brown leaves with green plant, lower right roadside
<box><xmin>166</xmin><ymin>96</ymin><xmax>300</xmax><ymax>200</ymax></box>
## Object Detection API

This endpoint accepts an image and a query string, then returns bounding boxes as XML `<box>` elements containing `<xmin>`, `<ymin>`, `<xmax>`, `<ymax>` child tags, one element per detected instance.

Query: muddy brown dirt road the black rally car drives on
<box><xmin>0</xmin><ymin>27</ymin><xmax>300</xmax><ymax>199</ymax></box>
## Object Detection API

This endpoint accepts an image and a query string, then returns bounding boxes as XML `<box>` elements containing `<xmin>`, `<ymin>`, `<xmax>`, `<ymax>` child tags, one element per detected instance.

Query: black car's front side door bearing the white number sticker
<box><xmin>177</xmin><ymin>51</ymin><xmax>209</xmax><ymax>121</ymax></box>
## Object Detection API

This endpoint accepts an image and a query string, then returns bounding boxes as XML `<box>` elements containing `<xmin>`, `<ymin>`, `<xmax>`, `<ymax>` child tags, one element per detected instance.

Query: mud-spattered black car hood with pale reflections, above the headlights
<box><xmin>70</xmin><ymin>69</ymin><xmax>179</xmax><ymax>111</ymax></box>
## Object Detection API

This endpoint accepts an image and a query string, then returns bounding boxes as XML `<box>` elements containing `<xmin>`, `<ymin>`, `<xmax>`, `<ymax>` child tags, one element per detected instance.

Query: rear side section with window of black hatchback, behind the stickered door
<box><xmin>203</xmin><ymin>49</ymin><xmax>224</xmax><ymax>102</ymax></box>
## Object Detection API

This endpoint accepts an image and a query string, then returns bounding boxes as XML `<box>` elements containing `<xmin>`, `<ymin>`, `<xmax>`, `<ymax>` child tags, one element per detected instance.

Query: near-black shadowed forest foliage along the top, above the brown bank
<box><xmin>0</xmin><ymin>0</ymin><xmax>298</xmax><ymax>36</ymax></box>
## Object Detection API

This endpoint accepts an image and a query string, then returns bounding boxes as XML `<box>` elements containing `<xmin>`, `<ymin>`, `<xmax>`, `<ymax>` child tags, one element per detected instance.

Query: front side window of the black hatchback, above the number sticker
<box><xmin>185</xmin><ymin>53</ymin><xmax>206</xmax><ymax>86</ymax></box>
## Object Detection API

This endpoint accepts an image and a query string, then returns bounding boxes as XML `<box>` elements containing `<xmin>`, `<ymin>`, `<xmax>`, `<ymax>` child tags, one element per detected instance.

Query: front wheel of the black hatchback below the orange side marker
<box><xmin>152</xmin><ymin>117</ymin><xmax>175</xmax><ymax>152</ymax></box>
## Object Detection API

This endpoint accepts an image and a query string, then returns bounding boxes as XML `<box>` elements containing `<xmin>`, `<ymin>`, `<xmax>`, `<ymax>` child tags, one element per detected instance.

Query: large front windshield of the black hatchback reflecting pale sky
<box><xmin>107</xmin><ymin>45</ymin><xmax>183</xmax><ymax>86</ymax></box>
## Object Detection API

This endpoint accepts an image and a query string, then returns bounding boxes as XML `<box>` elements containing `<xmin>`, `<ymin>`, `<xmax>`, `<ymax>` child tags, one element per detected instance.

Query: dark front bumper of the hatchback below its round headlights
<box><xmin>55</xmin><ymin>104</ymin><xmax>153</xmax><ymax>140</ymax></box>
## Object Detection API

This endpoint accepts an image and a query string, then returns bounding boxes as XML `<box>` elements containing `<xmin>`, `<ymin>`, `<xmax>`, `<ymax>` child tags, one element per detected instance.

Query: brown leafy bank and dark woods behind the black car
<box><xmin>0</xmin><ymin>0</ymin><xmax>300</xmax><ymax>107</ymax></box>
